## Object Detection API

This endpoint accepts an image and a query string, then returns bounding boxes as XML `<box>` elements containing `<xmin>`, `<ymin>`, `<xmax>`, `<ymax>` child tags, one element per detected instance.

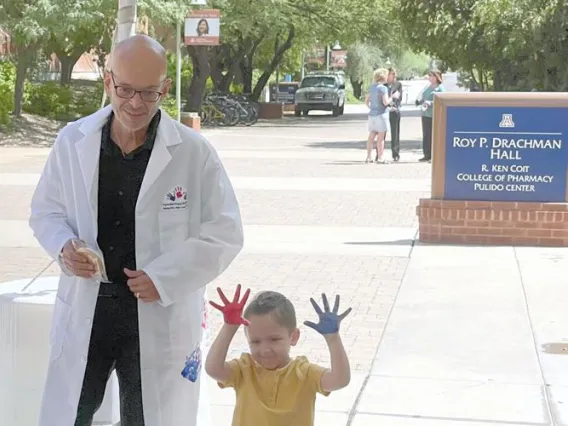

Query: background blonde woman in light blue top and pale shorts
<box><xmin>365</xmin><ymin>68</ymin><xmax>400</xmax><ymax>163</ymax></box>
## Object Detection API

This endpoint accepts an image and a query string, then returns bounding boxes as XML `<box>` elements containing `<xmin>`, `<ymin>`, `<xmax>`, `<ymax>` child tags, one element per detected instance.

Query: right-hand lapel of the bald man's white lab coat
<box><xmin>136</xmin><ymin>111</ymin><xmax>181</xmax><ymax>208</ymax></box>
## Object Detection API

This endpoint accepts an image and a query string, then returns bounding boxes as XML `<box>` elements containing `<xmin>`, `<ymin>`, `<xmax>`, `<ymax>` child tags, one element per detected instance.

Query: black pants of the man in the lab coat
<box><xmin>75</xmin><ymin>284</ymin><xmax>144</xmax><ymax>426</ymax></box>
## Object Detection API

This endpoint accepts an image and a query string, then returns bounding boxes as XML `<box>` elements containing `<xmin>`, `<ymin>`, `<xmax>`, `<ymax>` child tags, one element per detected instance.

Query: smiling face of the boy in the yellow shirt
<box><xmin>245</xmin><ymin>314</ymin><xmax>300</xmax><ymax>370</ymax></box>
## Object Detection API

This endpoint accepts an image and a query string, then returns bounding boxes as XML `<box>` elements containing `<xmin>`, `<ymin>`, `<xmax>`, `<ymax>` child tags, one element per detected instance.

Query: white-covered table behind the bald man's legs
<box><xmin>0</xmin><ymin>277</ymin><xmax>120</xmax><ymax>426</ymax></box>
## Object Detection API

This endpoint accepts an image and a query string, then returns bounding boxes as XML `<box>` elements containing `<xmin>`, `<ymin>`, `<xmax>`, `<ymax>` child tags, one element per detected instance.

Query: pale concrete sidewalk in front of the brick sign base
<box><xmin>203</xmin><ymin>244</ymin><xmax>568</xmax><ymax>426</ymax></box>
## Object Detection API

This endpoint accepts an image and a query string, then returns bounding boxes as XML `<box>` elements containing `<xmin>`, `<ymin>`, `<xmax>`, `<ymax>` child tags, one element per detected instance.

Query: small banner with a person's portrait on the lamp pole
<box><xmin>184</xmin><ymin>9</ymin><xmax>221</xmax><ymax>46</ymax></box>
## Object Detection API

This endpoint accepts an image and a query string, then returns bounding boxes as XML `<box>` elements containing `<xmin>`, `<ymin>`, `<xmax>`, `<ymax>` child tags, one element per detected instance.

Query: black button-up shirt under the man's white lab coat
<box><xmin>97</xmin><ymin>110</ymin><xmax>160</xmax><ymax>290</ymax></box>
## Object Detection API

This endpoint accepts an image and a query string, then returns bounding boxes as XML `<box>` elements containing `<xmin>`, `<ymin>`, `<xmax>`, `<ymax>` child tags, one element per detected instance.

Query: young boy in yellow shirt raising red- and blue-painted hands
<box><xmin>205</xmin><ymin>285</ymin><xmax>351</xmax><ymax>426</ymax></box>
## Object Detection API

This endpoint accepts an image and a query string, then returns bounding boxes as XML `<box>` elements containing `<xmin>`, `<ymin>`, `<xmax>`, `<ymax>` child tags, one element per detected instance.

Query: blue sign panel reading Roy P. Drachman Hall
<box><xmin>444</xmin><ymin>106</ymin><xmax>568</xmax><ymax>202</ymax></box>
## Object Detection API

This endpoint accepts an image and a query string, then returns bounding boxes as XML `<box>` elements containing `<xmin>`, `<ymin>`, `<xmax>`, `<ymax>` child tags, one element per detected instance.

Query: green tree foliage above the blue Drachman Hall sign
<box><xmin>398</xmin><ymin>0</ymin><xmax>568</xmax><ymax>91</ymax></box>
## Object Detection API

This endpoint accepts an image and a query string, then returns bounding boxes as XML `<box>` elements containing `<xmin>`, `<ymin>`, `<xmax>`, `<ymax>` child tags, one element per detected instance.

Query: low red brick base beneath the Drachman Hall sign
<box><xmin>416</xmin><ymin>198</ymin><xmax>568</xmax><ymax>247</ymax></box>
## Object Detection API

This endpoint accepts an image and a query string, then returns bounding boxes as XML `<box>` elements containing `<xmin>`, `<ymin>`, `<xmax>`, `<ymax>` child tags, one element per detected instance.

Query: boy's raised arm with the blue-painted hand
<box><xmin>304</xmin><ymin>294</ymin><xmax>351</xmax><ymax>392</ymax></box>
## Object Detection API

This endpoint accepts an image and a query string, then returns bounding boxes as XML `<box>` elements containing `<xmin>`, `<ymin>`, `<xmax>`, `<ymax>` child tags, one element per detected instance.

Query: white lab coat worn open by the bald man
<box><xmin>30</xmin><ymin>107</ymin><xmax>243</xmax><ymax>426</ymax></box>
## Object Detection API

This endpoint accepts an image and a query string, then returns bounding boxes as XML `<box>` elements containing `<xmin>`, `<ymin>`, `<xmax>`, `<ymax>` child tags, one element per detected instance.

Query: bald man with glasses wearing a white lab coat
<box><xmin>30</xmin><ymin>36</ymin><xmax>243</xmax><ymax>426</ymax></box>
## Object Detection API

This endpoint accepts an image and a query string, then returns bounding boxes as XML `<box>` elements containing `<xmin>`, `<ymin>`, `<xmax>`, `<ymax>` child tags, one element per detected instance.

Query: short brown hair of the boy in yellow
<box><xmin>243</xmin><ymin>291</ymin><xmax>296</xmax><ymax>331</ymax></box>
